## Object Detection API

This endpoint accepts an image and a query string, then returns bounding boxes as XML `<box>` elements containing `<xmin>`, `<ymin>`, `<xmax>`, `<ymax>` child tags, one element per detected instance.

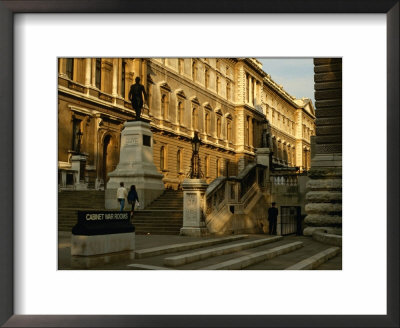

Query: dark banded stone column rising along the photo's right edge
<box><xmin>303</xmin><ymin>58</ymin><xmax>342</xmax><ymax>235</ymax></box>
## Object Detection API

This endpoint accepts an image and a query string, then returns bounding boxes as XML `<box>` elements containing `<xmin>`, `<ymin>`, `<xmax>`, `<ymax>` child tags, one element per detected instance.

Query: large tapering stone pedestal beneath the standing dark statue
<box><xmin>105</xmin><ymin>121</ymin><xmax>164</xmax><ymax>209</ymax></box>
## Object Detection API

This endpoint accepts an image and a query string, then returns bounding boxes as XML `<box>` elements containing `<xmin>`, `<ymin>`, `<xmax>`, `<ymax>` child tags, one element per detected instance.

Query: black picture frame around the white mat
<box><xmin>0</xmin><ymin>0</ymin><xmax>400</xmax><ymax>327</ymax></box>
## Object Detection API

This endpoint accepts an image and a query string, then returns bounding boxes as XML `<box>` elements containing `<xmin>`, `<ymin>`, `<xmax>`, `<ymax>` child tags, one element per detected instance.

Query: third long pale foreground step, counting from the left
<box><xmin>201</xmin><ymin>241</ymin><xmax>303</xmax><ymax>270</ymax></box>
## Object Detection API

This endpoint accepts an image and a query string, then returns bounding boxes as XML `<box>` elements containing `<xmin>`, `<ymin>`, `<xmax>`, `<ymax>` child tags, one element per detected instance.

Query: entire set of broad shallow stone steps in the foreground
<box><xmin>124</xmin><ymin>235</ymin><xmax>342</xmax><ymax>270</ymax></box>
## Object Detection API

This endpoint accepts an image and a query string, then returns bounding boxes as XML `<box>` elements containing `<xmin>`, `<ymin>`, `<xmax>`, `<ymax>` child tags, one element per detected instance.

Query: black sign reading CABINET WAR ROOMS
<box><xmin>72</xmin><ymin>211</ymin><xmax>135</xmax><ymax>236</ymax></box>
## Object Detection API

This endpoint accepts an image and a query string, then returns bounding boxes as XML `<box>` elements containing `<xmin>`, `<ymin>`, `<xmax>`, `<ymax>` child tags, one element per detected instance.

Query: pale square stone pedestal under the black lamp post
<box><xmin>180</xmin><ymin>179</ymin><xmax>208</xmax><ymax>237</ymax></box>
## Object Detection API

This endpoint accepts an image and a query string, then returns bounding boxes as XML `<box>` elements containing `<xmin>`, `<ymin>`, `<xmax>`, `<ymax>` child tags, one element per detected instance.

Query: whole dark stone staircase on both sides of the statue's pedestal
<box><xmin>58</xmin><ymin>190</ymin><xmax>183</xmax><ymax>235</ymax></box>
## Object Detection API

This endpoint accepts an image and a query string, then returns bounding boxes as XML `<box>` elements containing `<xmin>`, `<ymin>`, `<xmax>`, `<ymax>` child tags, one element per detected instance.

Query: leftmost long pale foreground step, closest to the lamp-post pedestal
<box><xmin>135</xmin><ymin>235</ymin><xmax>247</xmax><ymax>259</ymax></box>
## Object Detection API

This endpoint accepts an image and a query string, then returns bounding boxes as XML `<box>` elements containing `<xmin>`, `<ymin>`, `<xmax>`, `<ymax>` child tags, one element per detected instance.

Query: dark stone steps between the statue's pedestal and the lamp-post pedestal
<box><xmin>132</xmin><ymin>190</ymin><xmax>183</xmax><ymax>235</ymax></box>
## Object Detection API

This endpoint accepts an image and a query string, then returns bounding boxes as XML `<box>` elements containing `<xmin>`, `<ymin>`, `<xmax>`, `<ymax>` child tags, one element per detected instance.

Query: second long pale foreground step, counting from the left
<box><xmin>164</xmin><ymin>236</ymin><xmax>283</xmax><ymax>267</ymax></box>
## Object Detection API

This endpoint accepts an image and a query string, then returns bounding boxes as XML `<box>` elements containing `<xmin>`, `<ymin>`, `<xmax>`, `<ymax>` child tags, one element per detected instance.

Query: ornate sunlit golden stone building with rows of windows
<box><xmin>58</xmin><ymin>58</ymin><xmax>315</xmax><ymax>188</ymax></box>
